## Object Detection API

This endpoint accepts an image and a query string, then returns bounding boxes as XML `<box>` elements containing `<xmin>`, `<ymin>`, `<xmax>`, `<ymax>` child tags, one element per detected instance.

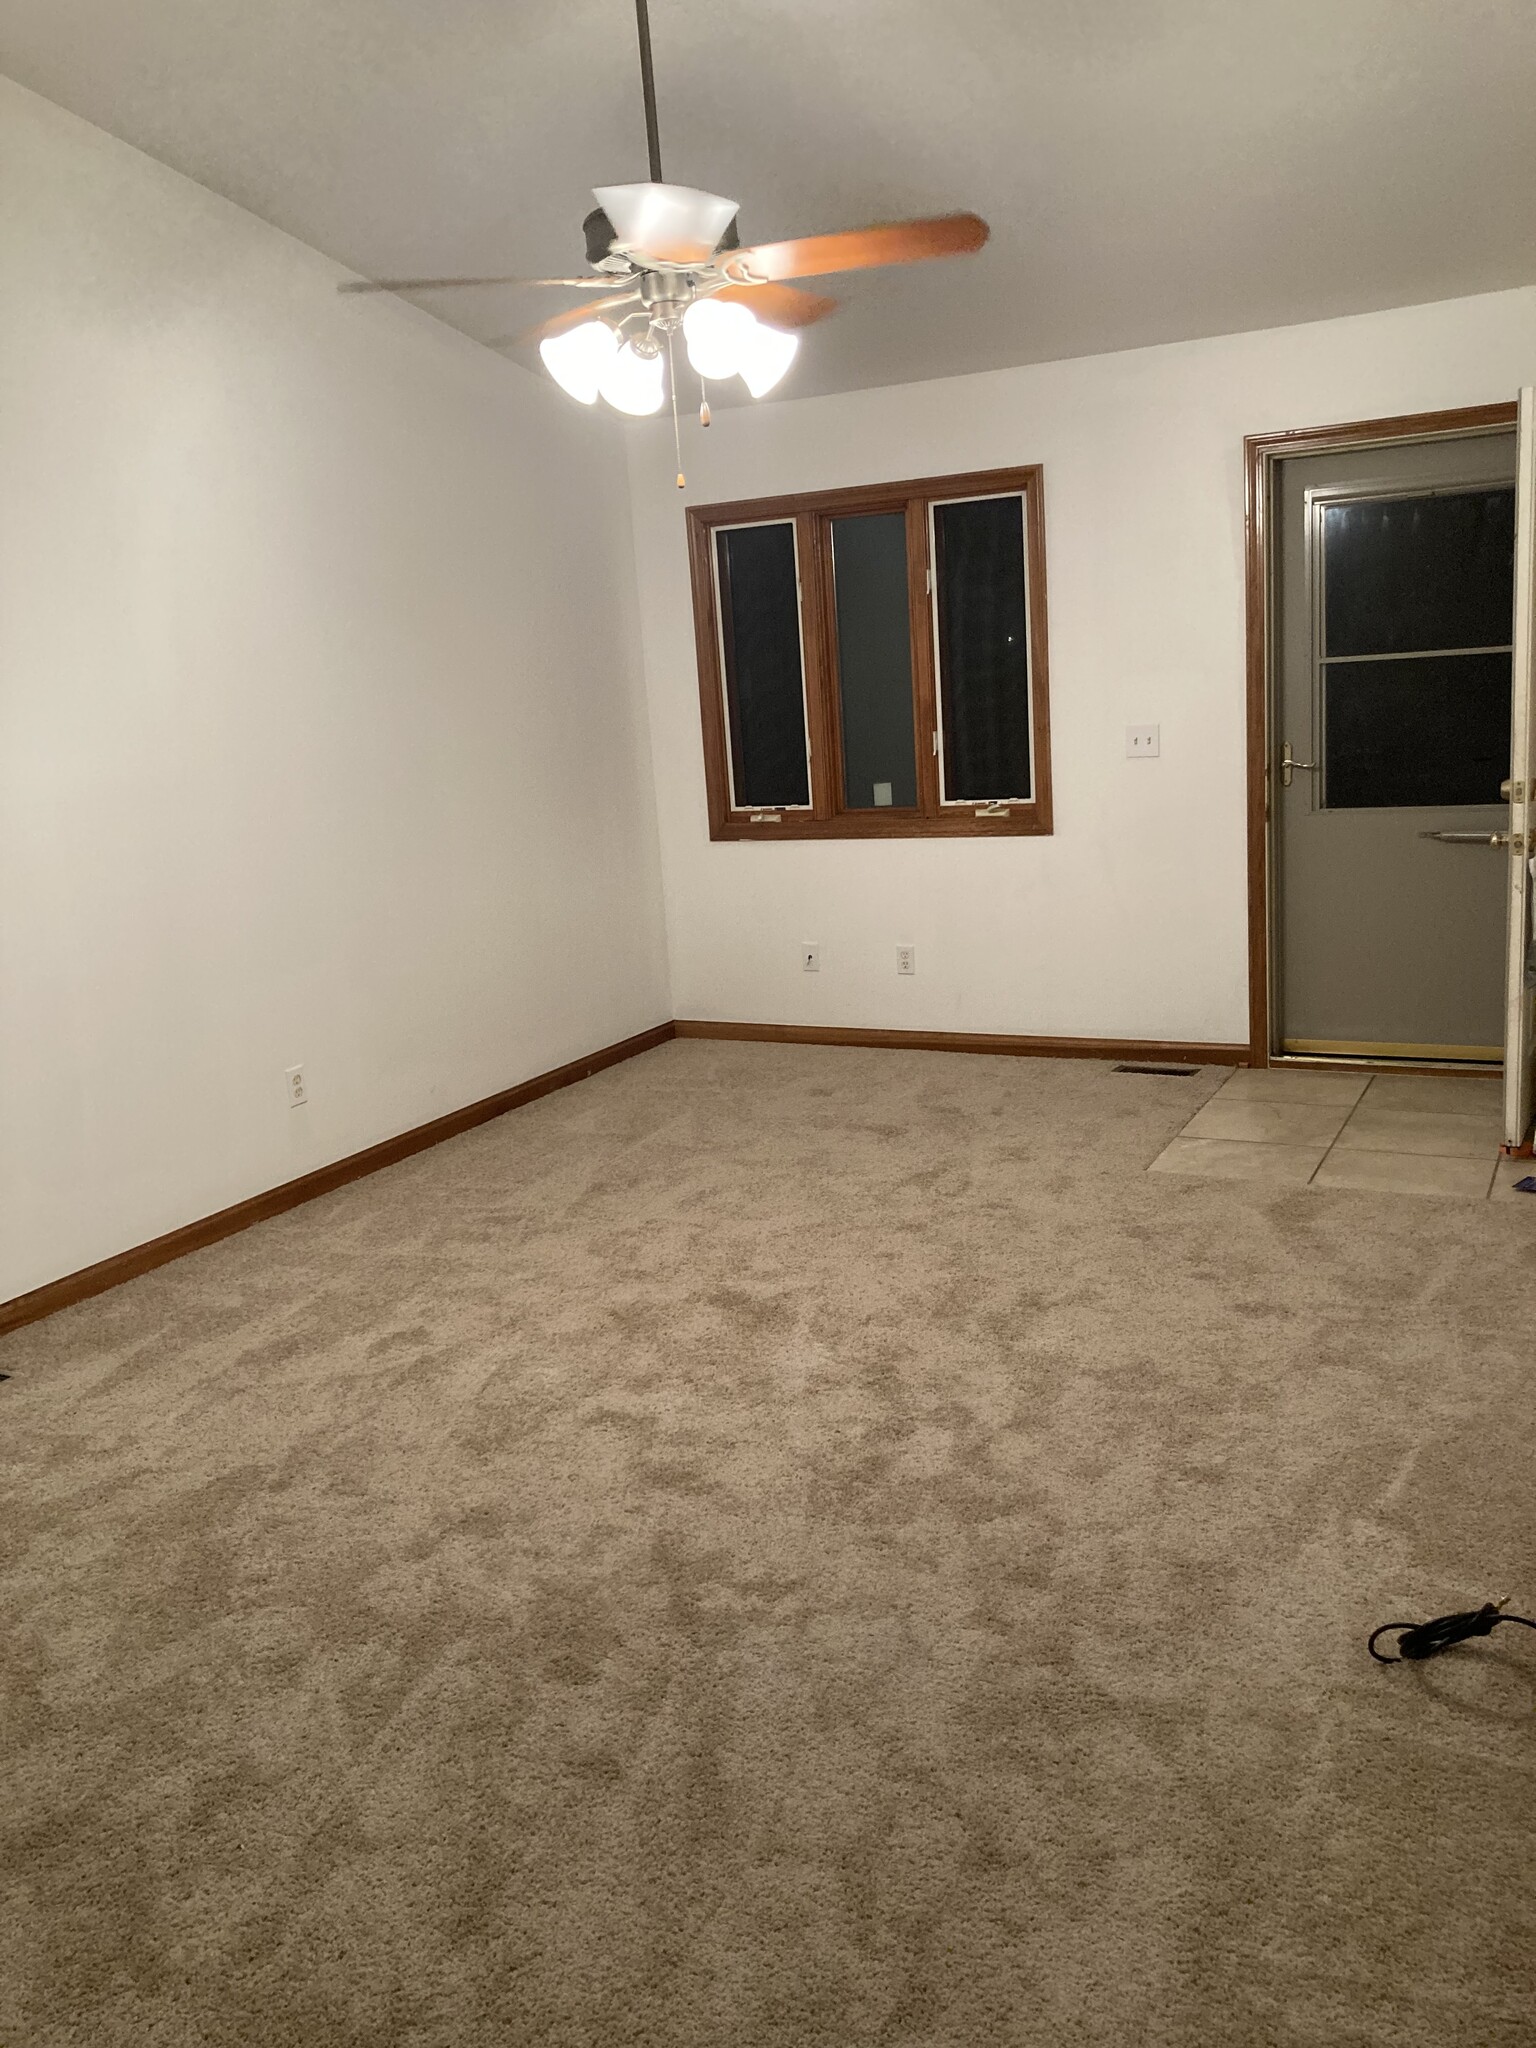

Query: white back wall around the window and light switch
<box><xmin>631</xmin><ymin>284</ymin><xmax>1536</xmax><ymax>1042</ymax></box>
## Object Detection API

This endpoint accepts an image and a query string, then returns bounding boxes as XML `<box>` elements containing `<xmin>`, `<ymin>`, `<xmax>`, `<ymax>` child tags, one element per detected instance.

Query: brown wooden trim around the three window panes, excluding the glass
<box><xmin>688</xmin><ymin>463</ymin><xmax>1051</xmax><ymax>840</ymax></box>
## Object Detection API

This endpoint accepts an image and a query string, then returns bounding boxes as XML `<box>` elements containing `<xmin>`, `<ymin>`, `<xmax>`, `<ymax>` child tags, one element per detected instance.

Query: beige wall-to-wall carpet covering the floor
<box><xmin>0</xmin><ymin>1042</ymin><xmax>1536</xmax><ymax>2048</ymax></box>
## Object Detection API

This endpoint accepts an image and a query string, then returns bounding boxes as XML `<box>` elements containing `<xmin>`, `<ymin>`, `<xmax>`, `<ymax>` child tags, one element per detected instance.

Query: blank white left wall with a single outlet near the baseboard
<box><xmin>0</xmin><ymin>82</ymin><xmax>670</xmax><ymax>1298</ymax></box>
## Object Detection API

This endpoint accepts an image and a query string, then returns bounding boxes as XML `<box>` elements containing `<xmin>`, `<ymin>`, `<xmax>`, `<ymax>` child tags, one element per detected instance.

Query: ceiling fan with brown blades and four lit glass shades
<box><xmin>338</xmin><ymin>0</ymin><xmax>989</xmax><ymax>475</ymax></box>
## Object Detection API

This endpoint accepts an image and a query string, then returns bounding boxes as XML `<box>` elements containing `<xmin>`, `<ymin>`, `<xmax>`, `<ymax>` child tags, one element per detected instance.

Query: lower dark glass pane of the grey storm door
<box><xmin>1323</xmin><ymin>653</ymin><xmax>1511</xmax><ymax>811</ymax></box>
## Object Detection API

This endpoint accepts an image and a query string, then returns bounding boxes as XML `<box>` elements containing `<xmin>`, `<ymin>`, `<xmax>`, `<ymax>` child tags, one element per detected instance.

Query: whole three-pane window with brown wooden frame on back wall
<box><xmin>688</xmin><ymin>467</ymin><xmax>1051</xmax><ymax>840</ymax></box>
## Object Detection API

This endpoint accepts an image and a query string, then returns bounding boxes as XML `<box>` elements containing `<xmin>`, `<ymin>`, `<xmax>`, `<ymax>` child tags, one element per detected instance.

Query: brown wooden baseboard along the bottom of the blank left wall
<box><xmin>0</xmin><ymin>1024</ymin><xmax>674</xmax><ymax>1335</ymax></box>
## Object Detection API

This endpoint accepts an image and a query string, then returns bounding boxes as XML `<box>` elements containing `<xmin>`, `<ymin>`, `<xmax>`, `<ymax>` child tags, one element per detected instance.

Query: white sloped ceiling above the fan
<box><xmin>0</xmin><ymin>0</ymin><xmax>1536</xmax><ymax>395</ymax></box>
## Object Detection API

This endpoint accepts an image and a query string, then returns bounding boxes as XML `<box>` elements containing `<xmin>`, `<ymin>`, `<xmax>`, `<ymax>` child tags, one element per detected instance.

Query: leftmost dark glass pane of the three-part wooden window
<box><xmin>715</xmin><ymin>520</ymin><xmax>811</xmax><ymax>811</ymax></box>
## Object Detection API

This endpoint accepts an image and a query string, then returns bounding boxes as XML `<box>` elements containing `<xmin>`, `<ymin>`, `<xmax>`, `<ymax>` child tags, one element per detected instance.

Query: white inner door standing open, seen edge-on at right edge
<box><xmin>1503</xmin><ymin>385</ymin><xmax>1536</xmax><ymax>1151</ymax></box>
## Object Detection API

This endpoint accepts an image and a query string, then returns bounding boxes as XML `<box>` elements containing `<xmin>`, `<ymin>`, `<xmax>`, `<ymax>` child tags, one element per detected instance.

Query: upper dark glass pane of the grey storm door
<box><xmin>1323</xmin><ymin>487</ymin><xmax>1516</xmax><ymax>655</ymax></box>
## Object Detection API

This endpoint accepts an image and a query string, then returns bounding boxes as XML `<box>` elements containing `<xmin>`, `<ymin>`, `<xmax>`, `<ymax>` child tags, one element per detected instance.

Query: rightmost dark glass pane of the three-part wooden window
<box><xmin>934</xmin><ymin>498</ymin><xmax>1032</xmax><ymax>803</ymax></box>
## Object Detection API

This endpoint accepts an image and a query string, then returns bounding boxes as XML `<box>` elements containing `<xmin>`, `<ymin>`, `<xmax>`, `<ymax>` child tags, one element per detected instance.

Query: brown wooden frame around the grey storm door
<box><xmin>1243</xmin><ymin>399</ymin><xmax>1518</xmax><ymax>1073</ymax></box>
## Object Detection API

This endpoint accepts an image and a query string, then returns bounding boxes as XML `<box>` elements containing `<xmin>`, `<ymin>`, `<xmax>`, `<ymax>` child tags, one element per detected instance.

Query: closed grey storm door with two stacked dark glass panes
<box><xmin>1270</xmin><ymin>428</ymin><xmax>1516</xmax><ymax>1065</ymax></box>
